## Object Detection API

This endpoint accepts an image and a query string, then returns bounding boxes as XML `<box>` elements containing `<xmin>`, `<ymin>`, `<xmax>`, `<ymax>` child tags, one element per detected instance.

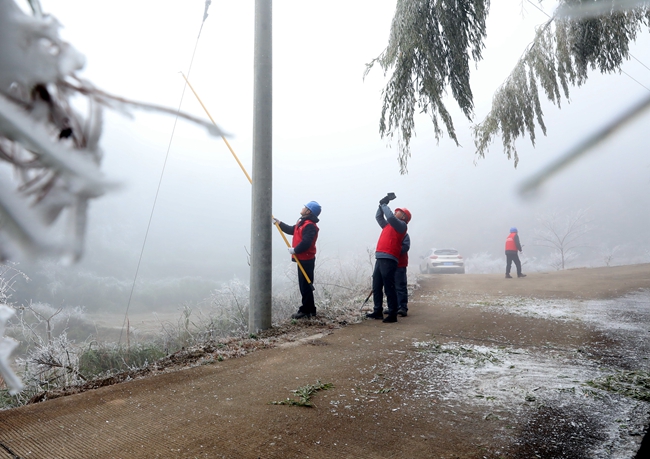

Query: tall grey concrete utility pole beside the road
<box><xmin>248</xmin><ymin>0</ymin><xmax>273</xmax><ymax>333</ymax></box>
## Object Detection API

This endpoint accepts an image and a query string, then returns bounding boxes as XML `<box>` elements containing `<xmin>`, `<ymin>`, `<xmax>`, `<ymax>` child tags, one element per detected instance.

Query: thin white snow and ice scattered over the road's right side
<box><xmin>398</xmin><ymin>291</ymin><xmax>650</xmax><ymax>459</ymax></box>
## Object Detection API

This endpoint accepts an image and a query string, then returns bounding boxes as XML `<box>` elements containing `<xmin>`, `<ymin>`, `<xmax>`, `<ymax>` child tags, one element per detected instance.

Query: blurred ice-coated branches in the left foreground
<box><xmin>0</xmin><ymin>0</ymin><xmax>224</xmax><ymax>261</ymax></box>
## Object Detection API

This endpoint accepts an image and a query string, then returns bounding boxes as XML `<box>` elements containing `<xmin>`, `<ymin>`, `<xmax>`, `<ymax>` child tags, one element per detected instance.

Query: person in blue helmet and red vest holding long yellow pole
<box><xmin>273</xmin><ymin>201</ymin><xmax>321</xmax><ymax>319</ymax></box>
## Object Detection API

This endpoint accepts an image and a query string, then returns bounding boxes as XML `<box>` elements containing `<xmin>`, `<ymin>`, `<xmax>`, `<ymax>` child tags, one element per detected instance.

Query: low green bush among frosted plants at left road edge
<box><xmin>79</xmin><ymin>344</ymin><xmax>165</xmax><ymax>379</ymax></box>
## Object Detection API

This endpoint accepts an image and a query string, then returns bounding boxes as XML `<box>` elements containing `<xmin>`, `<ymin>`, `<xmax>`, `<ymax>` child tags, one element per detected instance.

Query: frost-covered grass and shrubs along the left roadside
<box><xmin>0</xmin><ymin>259</ymin><xmax>372</xmax><ymax>408</ymax></box>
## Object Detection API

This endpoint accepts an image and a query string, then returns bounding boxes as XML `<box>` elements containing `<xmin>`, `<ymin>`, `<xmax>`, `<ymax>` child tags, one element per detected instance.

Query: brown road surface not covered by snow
<box><xmin>0</xmin><ymin>264</ymin><xmax>650</xmax><ymax>459</ymax></box>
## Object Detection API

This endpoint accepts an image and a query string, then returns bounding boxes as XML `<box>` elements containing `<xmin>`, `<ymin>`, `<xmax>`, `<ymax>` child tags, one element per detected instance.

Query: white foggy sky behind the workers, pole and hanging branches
<box><xmin>8</xmin><ymin>0</ymin><xmax>650</xmax><ymax>309</ymax></box>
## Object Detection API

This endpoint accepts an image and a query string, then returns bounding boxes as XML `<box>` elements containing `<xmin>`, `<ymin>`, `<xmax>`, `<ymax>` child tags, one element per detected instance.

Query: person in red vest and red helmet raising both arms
<box><xmin>366</xmin><ymin>193</ymin><xmax>411</xmax><ymax>323</ymax></box>
